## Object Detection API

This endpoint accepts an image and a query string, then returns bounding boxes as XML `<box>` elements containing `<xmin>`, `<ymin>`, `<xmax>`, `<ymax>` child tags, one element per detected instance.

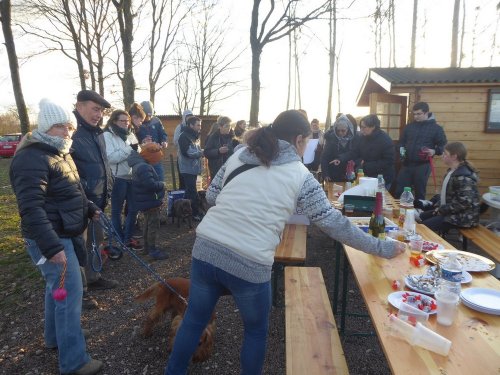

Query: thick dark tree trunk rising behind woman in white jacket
<box><xmin>113</xmin><ymin>0</ymin><xmax>136</xmax><ymax>108</ymax></box>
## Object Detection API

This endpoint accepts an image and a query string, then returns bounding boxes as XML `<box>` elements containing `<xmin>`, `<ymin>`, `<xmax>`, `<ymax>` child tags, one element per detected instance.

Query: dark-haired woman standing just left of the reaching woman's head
<box><xmin>203</xmin><ymin>116</ymin><xmax>234</xmax><ymax>180</ymax></box>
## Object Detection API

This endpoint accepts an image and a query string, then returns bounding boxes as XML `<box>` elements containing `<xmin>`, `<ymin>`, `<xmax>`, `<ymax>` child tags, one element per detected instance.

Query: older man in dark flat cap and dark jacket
<box><xmin>72</xmin><ymin>90</ymin><xmax>117</xmax><ymax>308</ymax></box>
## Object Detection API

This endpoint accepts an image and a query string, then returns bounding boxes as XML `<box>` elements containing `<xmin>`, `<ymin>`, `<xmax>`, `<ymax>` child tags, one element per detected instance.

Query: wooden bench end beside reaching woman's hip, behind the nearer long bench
<box><xmin>274</xmin><ymin>224</ymin><xmax>307</xmax><ymax>263</ymax></box>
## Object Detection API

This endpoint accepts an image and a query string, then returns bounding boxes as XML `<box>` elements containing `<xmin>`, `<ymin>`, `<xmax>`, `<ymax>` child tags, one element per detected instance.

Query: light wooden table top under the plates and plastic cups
<box><xmin>345</xmin><ymin>225</ymin><xmax>500</xmax><ymax>375</ymax></box>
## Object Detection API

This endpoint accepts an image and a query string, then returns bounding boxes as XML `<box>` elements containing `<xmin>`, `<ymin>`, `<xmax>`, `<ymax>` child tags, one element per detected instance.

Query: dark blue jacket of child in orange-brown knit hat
<box><xmin>127</xmin><ymin>151</ymin><xmax>165</xmax><ymax>211</ymax></box>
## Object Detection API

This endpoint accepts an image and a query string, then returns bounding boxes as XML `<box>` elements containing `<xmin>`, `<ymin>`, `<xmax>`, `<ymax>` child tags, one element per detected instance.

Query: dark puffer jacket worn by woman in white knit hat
<box><xmin>9</xmin><ymin>135</ymin><xmax>97</xmax><ymax>259</ymax></box>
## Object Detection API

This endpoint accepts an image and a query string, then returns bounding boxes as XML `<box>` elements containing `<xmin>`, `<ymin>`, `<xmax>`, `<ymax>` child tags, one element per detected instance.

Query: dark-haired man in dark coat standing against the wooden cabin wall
<box><xmin>395</xmin><ymin>102</ymin><xmax>446</xmax><ymax>199</ymax></box>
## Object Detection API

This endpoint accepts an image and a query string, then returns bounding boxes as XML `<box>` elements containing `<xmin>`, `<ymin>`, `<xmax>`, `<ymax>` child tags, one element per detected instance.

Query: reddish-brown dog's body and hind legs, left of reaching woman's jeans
<box><xmin>135</xmin><ymin>277</ymin><xmax>189</xmax><ymax>336</ymax></box>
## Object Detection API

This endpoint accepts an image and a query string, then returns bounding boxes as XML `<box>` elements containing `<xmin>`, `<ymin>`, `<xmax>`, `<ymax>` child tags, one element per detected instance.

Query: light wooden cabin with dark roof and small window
<box><xmin>357</xmin><ymin>67</ymin><xmax>500</xmax><ymax>197</ymax></box>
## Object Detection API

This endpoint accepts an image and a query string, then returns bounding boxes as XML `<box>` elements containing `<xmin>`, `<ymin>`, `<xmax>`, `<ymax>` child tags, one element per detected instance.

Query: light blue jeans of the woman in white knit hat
<box><xmin>24</xmin><ymin>238</ymin><xmax>90</xmax><ymax>374</ymax></box>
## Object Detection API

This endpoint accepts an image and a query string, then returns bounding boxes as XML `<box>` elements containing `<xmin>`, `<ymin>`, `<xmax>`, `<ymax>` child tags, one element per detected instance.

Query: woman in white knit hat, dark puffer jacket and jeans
<box><xmin>10</xmin><ymin>99</ymin><xmax>102</xmax><ymax>375</ymax></box>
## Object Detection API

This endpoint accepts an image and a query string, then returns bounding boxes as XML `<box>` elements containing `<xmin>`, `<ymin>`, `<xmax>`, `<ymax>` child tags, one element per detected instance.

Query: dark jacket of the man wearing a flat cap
<box><xmin>71</xmin><ymin>111</ymin><xmax>113</xmax><ymax>210</ymax></box>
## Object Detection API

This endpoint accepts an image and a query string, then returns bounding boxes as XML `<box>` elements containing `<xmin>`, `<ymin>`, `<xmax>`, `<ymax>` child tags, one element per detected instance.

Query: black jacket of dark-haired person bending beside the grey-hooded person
<box><xmin>340</xmin><ymin>129</ymin><xmax>395</xmax><ymax>184</ymax></box>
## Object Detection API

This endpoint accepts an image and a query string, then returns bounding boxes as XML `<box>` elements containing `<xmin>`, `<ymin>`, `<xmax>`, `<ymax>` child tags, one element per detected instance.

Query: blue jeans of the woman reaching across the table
<box><xmin>165</xmin><ymin>258</ymin><xmax>271</xmax><ymax>375</ymax></box>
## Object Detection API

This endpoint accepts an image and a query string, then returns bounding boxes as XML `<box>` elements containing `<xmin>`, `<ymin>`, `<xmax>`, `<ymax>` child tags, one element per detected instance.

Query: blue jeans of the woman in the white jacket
<box><xmin>111</xmin><ymin>177</ymin><xmax>137</xmax><ymax>243</ymax></box>
